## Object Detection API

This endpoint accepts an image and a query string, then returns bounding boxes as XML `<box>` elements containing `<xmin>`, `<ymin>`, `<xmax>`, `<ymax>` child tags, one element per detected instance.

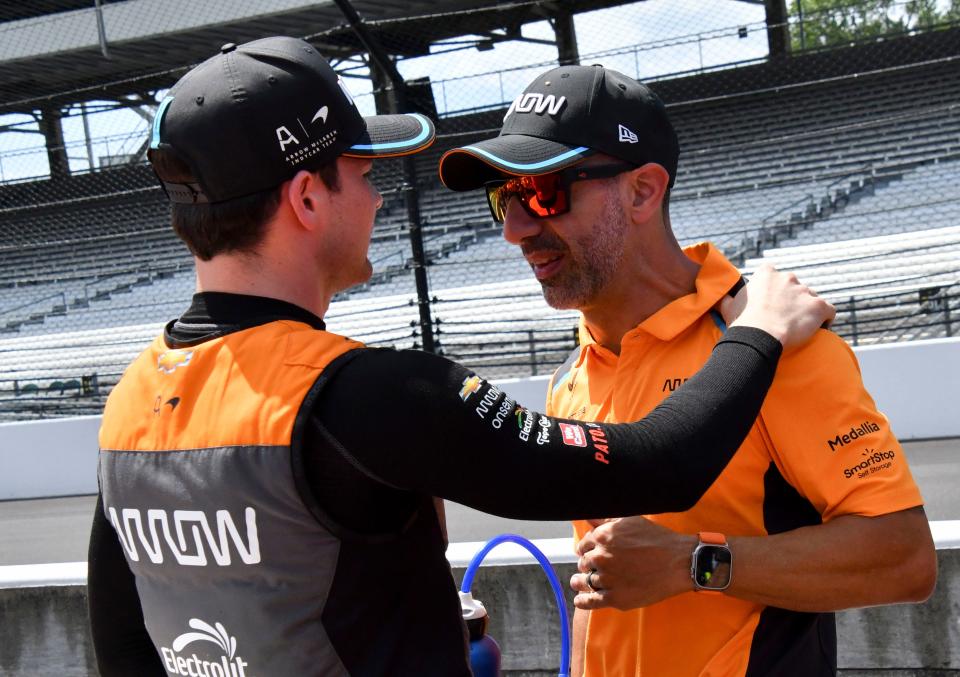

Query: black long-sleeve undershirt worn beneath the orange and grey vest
<box><xmin>89</xmin><ymin>294</ymin><xmax>781</xmax><ymax>677</ymax></box>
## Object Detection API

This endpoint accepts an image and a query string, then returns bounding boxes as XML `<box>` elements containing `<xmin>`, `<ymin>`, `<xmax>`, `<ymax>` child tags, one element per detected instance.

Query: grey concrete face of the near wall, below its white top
<box><xmin>0</xmin><ymin>549</ymin><xmax>960</xmax><ymax>677</ymax></box>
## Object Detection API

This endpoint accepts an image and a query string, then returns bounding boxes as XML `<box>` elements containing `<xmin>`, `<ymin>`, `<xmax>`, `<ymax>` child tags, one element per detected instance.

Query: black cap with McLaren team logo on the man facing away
<box><xmin>148</xmin><ymin>37</ymin><xmax>435</xmax><ymax>204</ymax></box>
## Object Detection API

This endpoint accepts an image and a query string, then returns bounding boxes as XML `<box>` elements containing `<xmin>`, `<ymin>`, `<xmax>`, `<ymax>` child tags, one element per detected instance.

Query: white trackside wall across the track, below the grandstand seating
<box><xmin>0</xmin><ymin>338</ymin><xmax>960</xmax><ymax>500</ymax></box>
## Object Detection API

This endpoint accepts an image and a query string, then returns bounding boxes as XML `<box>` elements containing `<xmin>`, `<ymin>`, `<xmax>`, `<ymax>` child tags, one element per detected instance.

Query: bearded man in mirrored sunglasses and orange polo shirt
<box><xmin>440</xmin><ymin>66</ymin><xmax>936</xmax><ymax>677</ymax></box>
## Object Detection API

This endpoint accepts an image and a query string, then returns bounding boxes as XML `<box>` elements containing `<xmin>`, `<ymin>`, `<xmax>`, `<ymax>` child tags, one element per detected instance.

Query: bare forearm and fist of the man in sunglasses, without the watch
<box><xmin>570</xmin><ymin>508</ymin><xmax>937</xmax><ymax>611</ymax></box>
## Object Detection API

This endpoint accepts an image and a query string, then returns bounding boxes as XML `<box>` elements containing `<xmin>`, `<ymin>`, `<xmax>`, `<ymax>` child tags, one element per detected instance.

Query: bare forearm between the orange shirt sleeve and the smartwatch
<box><xmin>726</xmin><ymin>508</ymin><xmax>937</xmax><ymax>612</ymax></box>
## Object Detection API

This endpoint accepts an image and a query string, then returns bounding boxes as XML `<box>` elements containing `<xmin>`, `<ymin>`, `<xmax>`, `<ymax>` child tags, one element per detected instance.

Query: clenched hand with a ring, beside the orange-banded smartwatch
<box><xmin>570</xmin><ymin>516</ymin><xmax>697</xmax><ymax>610</ymax></box>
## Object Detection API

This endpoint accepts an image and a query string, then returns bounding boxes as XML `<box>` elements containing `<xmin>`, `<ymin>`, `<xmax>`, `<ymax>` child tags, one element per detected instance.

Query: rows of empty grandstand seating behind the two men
<box><xmin>0</xmin><ymin>43</ymin><xmax>960</xmax><ymax>416</ymax></box>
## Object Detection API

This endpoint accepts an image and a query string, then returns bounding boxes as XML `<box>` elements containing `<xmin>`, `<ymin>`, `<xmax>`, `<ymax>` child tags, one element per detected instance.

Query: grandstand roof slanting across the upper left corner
<box><xmin>0</xmin><ymin>0</ymin><xmax>634</xmax><ymax>114</ymax></box>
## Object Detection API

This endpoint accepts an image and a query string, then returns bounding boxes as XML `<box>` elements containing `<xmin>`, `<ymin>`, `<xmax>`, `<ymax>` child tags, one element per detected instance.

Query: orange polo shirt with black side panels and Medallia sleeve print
<box><xmin>547</xmin><ymin>244</ymin><xmax>922</xmax><ymax>677</ymax></box>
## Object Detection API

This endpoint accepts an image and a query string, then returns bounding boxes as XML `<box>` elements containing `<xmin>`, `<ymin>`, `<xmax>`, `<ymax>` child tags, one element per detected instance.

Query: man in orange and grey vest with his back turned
<box><xmin>89</xmin><ymin>43</ymin><xmax>832</xmax><ymax>677</ymax></box>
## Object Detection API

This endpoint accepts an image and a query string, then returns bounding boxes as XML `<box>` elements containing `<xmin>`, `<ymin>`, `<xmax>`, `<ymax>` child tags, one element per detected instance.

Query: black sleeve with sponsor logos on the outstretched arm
<box><xmin>306</xmin><ymin>327</ymin><xmax>780</xmax><ymax>531</ymax></box>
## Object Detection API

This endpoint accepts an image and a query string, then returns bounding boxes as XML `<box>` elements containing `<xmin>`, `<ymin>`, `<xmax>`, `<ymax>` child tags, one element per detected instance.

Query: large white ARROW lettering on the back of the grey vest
<box><xmin>108</xmin><ymin>507</ymin><xmax>260</xmax><ymax>567</ymax></box>
